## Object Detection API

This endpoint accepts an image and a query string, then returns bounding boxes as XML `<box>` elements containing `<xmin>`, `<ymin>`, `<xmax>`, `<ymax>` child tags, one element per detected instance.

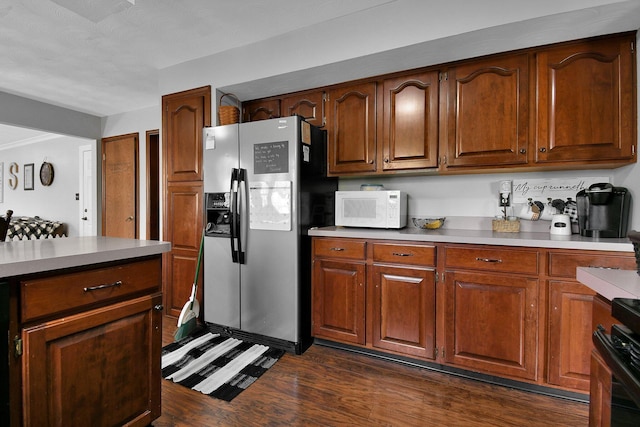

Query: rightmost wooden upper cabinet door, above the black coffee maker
<box><xmin>536</xmin><ymin>35</ymin><xmax>636</xmax><ymax>163</ymax></box>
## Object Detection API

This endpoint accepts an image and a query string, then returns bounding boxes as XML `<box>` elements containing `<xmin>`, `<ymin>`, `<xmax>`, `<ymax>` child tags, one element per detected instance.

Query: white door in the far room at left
<box><xmin>78</xmin><ymin>145</ymin><xmax>97</xmax><ymax>236</ymax></box>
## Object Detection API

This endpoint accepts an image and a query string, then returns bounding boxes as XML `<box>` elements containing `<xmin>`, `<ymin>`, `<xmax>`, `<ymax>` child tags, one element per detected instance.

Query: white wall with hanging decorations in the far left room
<box><xmin>0</xmin><ymin>136</ymin><xmax>96</xmax><ymax>236</ymax></box>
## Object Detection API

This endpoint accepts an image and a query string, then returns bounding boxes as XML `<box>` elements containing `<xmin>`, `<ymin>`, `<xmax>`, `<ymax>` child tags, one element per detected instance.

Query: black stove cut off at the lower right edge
<box><xmin>593</xmin><ymin>298</ymin><xmax>640</xmax><ymax>426</ymax></box>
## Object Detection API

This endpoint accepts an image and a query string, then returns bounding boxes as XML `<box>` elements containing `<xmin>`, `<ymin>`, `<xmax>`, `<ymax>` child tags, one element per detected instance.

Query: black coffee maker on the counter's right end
<box><xmin>576</xmin><ymin>183</ymin><xmax>631</xmax><ymax>238</ymax></box>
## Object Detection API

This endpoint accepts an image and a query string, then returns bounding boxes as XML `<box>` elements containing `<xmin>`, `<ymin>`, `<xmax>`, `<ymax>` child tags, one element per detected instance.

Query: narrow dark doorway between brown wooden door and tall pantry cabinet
<box><xmin>146</xmin><ymin>129</ymin><xmax>160</xmax><ymax>240</ymax></box>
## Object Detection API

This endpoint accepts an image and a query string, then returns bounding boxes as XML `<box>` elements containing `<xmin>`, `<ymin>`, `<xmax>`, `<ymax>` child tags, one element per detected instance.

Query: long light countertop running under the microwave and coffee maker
<box><xmin>309</xmin><ymin>226</ymin><xmax>633</xmax><ymax>252</ymax></box>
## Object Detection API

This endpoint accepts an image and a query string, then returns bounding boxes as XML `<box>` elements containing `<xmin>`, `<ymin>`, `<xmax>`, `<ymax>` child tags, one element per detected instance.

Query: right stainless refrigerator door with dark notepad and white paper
<box><xmin>240</xmin><ymin>117</ymin><xmax>300</xmax><ymax>342</ymax></box>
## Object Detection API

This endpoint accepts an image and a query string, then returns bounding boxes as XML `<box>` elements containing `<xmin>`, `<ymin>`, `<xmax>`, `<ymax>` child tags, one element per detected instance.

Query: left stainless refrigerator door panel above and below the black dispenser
<box><xmin>203</xmin><ymin>125</ymin><xmax>241</xmax><ymax>328</ymax></box>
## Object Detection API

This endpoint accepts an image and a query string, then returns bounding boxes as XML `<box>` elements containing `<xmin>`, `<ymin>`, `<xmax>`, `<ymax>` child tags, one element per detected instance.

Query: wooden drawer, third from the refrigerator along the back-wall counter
<box><xmin>445</xmin><ymin>247</ymin><xmax>538</xmax><ymax>275</ymax></box>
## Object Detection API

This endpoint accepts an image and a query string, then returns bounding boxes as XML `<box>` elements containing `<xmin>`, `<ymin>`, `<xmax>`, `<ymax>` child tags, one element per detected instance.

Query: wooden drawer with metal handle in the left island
<box><xmin>20</xmin><ymin>258</ymin><xmax>162</xmax><ymax>322</ymax></box>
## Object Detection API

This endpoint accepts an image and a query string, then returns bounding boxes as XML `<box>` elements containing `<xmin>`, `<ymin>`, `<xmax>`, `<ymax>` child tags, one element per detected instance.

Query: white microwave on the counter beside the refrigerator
<box><xmin>336</xmin><ymin>190</ymin><xmax>407</xmax><ymax>228</ymax></box>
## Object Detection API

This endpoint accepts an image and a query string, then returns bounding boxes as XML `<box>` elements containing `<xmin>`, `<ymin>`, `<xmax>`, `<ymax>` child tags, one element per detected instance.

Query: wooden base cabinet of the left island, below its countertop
<box><xmin>10</xmin><ymin>255</ymin><xmax>163</xmax><ymax>427</ymax></box>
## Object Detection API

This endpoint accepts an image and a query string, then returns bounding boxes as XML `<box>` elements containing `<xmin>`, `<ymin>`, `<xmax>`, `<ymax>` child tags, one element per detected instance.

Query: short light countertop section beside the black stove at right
<box><xmin>576</xmin><ymin>267</ymin><xmax>640</xmax><ymax>301</ymax></box>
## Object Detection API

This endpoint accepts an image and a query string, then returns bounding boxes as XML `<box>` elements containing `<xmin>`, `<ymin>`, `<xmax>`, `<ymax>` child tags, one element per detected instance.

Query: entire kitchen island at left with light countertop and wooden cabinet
<box><xmin>0</xmin><ymin>237</ymin><xmax>171</xmax><ymax>426</ymax></box>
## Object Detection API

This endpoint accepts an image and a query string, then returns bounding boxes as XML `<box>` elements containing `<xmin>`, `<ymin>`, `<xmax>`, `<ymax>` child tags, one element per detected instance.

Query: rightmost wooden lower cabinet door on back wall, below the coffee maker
<box><xmin>547</xmin><ymin>281</ymin><xmax>595</xmax><ymax>391</ymax></box>
